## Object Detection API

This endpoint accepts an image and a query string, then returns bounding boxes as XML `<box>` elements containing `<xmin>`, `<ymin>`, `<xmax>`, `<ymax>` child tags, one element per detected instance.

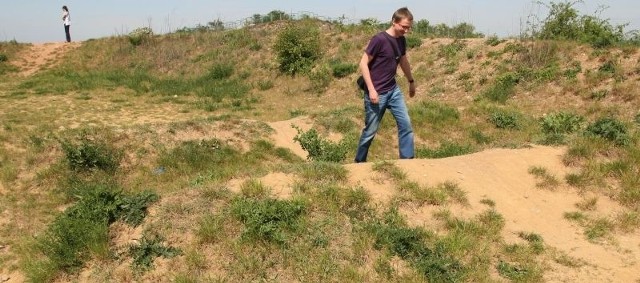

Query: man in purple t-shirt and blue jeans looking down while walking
<box><xmin>355</xmin><ymin>7</ymin><xmax>416</xmax><ymax>163</ymax></box>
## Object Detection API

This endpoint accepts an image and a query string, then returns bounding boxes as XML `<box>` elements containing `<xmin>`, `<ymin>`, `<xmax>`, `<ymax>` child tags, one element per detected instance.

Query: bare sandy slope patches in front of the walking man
<box><xmin>262</xmin><ymin>118</ymin><xmax>640</xmax><ymax>282</ymax></box>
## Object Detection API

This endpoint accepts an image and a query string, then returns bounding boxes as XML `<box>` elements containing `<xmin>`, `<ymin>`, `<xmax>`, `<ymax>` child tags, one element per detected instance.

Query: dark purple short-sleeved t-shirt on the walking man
<box><xmin>365</xmin><ymin>31</ymin><xmax>407</xmax><ymax>93</ymax></box>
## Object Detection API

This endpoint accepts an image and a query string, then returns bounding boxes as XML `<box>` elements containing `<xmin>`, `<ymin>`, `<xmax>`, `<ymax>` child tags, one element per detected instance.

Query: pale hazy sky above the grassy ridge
<box><xmin>0</xmin><ymin>0</ymin><xmax>640</xmax><ymax>43</ymax></box>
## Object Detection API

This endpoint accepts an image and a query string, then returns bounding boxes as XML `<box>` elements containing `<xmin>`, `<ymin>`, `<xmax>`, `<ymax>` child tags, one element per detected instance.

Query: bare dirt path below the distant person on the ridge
<box><xmin>14</xmin><ymin>42</ymin><xmax>81</xmax><ymax>76</ymax></box>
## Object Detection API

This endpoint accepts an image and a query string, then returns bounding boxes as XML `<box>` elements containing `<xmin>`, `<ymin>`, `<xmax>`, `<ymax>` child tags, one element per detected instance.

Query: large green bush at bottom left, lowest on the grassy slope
<box><xmin>27</xmin><ymin>184</ymin><xmax>158</xmax><ymax>281</ymax></box>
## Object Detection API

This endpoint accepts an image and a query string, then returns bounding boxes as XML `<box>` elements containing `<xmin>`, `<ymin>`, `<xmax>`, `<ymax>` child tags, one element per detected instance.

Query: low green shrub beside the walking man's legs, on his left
<box><xmin>292</xmin><ymin>126</ymin><xmax>348</xmax><ymax>162</ymax></box>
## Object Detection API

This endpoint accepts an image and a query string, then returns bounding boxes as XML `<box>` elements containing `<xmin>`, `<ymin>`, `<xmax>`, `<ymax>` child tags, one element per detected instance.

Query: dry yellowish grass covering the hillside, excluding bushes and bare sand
<box><xmin>0</xmin><ymin>18</ymin><xmax>640</xmax><ymax>282</ymax></box>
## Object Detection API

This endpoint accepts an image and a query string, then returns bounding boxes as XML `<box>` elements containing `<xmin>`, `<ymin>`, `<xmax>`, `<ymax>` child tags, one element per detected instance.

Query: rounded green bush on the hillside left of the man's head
<box><xmin>273</xmin><ymin>22</ymin><xmax>322</xmax><ymax>75</ymax></box>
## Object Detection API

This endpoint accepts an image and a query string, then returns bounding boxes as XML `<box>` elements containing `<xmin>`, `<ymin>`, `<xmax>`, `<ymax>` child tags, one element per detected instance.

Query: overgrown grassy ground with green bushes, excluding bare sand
<box><xmin>0</xmin><ymin>11</ymin><xmax>640</xmax><ymax>282</ymax></box>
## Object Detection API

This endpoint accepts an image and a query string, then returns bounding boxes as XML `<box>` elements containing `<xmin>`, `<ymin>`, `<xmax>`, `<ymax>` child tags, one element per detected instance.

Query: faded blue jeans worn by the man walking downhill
<box><xmin>355</xmin><ymin>86</ymin><xmax>415</xmax><ymax>162</ymax></box>
